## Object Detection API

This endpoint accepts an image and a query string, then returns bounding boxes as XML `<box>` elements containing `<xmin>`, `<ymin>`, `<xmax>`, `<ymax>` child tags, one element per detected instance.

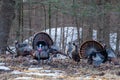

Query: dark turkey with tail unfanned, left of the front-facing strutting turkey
<box><xmin>15</xmin><ymin>42</ymin><xmax>32</xmax><ymax>57</ymax></box>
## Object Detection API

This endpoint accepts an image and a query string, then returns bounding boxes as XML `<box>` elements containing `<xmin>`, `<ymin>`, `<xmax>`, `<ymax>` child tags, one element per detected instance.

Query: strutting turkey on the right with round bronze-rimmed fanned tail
<box><xmin>80</xmin><ymin>40</ymin><xmax>107</xmax><ymax>66</ymax></box>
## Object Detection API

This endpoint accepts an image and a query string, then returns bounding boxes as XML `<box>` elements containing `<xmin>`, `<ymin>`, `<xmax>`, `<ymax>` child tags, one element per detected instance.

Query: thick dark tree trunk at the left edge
<box><xmin>0</xmin><ymin>0</ymin><xmax>15</xmax><ymax>53</ymax></box>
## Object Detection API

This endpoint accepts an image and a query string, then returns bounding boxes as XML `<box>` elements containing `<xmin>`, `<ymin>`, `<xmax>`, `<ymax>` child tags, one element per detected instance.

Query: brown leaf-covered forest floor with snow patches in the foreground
<box><xmin>0</xmin><ymin>54</ymin><xmax>120</xmax><ymax>80</ymax></box>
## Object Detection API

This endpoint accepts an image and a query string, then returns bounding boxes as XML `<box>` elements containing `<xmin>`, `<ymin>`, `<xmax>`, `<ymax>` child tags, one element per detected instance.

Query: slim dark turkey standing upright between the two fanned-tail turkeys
<box><xmin>71</xmin><ymin>43</ymin><xmax>80</xmax><ymax>62</ymax></box>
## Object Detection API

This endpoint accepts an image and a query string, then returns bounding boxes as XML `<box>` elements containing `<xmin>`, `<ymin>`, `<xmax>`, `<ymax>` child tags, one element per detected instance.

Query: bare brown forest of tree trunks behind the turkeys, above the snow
<box><xmin>0</xmin><ymin>0</ymin><xmax>120</xmax><ymax>53</ymax></box>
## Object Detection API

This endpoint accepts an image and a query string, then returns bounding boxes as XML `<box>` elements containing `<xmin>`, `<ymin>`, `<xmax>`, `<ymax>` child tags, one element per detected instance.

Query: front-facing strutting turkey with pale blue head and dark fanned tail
<box><xmin>32</xmin><ymin>32</ymin><xmax>67</xmax><ymax>62</ymax></box>
